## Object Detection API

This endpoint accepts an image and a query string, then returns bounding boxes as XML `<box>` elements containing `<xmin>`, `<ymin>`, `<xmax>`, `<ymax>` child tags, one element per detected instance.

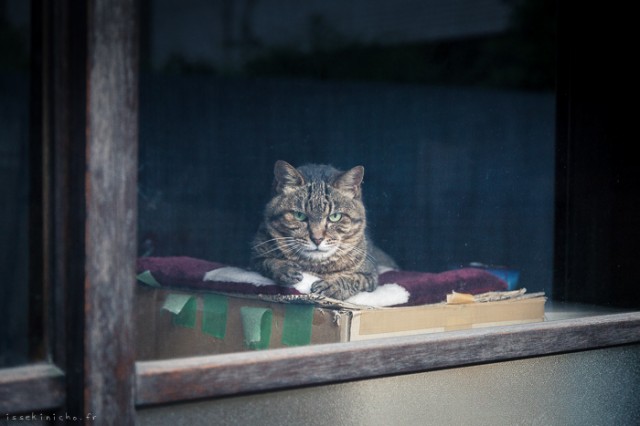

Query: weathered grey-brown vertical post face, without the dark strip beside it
<box><xmin>82</xmin><ymin>0</ymin><xmax>138</xmax><ymax>425</ymax></box>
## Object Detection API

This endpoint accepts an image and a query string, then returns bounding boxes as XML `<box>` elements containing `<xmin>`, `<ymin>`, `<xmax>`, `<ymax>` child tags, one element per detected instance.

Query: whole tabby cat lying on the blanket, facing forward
<box><xmin>252</xmin><ymin>161</ymin><xmax>396</xmax><ymax>300</ymax></box>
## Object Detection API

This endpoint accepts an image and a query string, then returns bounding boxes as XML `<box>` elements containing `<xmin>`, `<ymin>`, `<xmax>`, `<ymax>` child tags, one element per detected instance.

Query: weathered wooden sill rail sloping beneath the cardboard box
<box><xmin>136</xmin><ymin>312</ymin><xmax>640</xmax><ymax>406</ymax></box>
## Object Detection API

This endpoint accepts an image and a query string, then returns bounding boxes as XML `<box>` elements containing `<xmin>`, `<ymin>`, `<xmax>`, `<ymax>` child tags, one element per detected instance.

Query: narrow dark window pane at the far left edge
<box><xmin>0</xmin><ymin>0</ymin><xmax>30</xmax><ymax>367</ymax></box>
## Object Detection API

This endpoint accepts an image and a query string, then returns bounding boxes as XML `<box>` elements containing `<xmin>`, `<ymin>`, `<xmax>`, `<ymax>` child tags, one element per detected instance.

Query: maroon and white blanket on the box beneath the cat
<box><xmin>137</xmin><ymin>257</ymin><xmax>507</xmax><ymax>306</ymax></box>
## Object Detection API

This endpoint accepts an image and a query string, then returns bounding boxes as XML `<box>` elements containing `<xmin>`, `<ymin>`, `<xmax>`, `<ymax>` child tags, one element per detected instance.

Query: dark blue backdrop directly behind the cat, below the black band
<box><xmin>140</xmin><ymin>77</ymin><xmax>553</xmax><ymax>288</ymax></box>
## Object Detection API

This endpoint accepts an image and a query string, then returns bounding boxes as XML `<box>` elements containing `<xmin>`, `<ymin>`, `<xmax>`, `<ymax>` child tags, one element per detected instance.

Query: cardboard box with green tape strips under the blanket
<box><xmin>136</xmin><ymin>286</ymin><xmax>546</xmax><ymax>360</ymax></box>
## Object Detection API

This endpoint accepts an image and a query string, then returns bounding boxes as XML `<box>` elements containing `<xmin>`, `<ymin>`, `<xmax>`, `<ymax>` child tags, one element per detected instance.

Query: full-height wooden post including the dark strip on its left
<box><xmin>41</xmin><ymin>0</ymin><xmax>138</xmax><ymax>425</ymax></box>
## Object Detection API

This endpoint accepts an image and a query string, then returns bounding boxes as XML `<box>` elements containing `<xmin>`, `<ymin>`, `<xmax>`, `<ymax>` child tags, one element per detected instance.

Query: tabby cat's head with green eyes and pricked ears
<box><xmin>266</xmin><ymin>162</ymin><xmax>366</xmax><ymax>261</ymax></box>
